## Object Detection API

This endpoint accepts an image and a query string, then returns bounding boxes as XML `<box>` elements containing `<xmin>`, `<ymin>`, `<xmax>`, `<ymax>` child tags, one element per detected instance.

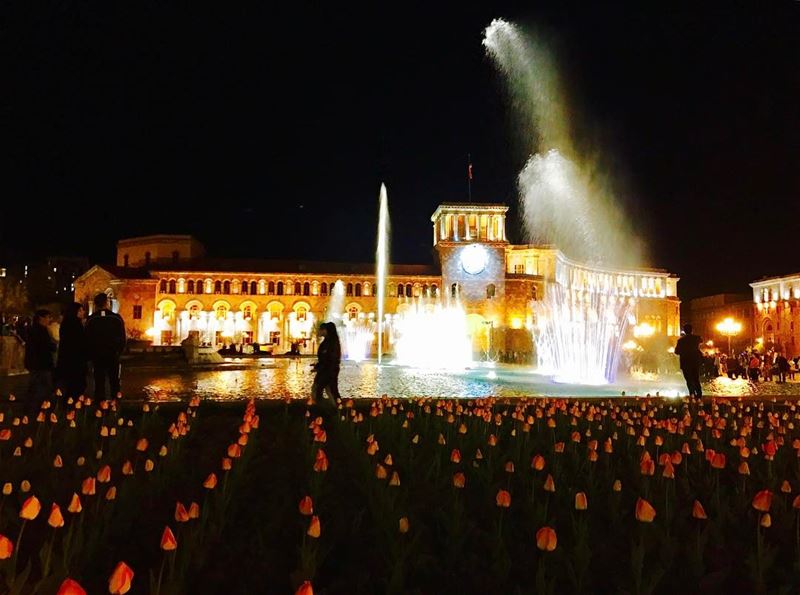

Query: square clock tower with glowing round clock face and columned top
<box><xmin>431</xmin><ymin>203</ymin><xmax>508</xmax><ymax>314</ymax></box>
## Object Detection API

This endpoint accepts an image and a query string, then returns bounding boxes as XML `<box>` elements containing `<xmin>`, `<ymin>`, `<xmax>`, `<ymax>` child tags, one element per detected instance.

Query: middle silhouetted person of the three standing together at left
<box><xmin>56</xmin><ymin>302</ymin><xmax>88</xmax><ymax>399</ymax></box>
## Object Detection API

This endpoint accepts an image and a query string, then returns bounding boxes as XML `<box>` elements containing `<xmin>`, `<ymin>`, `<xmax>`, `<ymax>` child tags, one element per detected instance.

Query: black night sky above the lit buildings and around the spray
<box><xmin>0</xmin><ymin>0</ymin><xmax>800</xmax><ymax>299</ymax></box>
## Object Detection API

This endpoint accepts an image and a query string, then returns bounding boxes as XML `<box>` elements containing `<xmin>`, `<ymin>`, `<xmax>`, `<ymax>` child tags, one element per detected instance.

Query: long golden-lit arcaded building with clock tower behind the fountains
<box><xmin>75</xmin><ymin>203</ymin><xmax>679</xmax><ymax>354</ymax></box>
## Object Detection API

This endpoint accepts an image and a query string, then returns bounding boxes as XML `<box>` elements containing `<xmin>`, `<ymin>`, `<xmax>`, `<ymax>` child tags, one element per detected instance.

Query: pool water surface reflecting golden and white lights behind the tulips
<box><xmin>124</xmin><ymin>359</ymin><xmax>800</xmax><ymax>401</ymax></box>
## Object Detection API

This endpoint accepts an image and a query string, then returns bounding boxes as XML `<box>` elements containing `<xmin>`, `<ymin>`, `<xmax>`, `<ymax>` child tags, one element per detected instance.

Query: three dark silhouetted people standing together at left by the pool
<box><xmin>23</xmin><ymin>293</ymin><xmax>126</xmax><ymax>408</ymax></box>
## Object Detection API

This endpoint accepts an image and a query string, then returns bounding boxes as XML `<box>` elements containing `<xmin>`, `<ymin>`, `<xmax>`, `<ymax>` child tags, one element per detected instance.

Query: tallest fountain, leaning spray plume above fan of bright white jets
<box><xmin>483</xmin><ymin>19</ymin><xmax>640</xmax><ymax>384</ymax></box>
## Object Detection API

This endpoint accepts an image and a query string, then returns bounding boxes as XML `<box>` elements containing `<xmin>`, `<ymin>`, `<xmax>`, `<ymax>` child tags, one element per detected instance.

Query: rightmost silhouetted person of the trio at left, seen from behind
<box><xmin>86</xmin><ymin>293</ymin><xmax>125</xmax><ymax>400</ymax></box>
